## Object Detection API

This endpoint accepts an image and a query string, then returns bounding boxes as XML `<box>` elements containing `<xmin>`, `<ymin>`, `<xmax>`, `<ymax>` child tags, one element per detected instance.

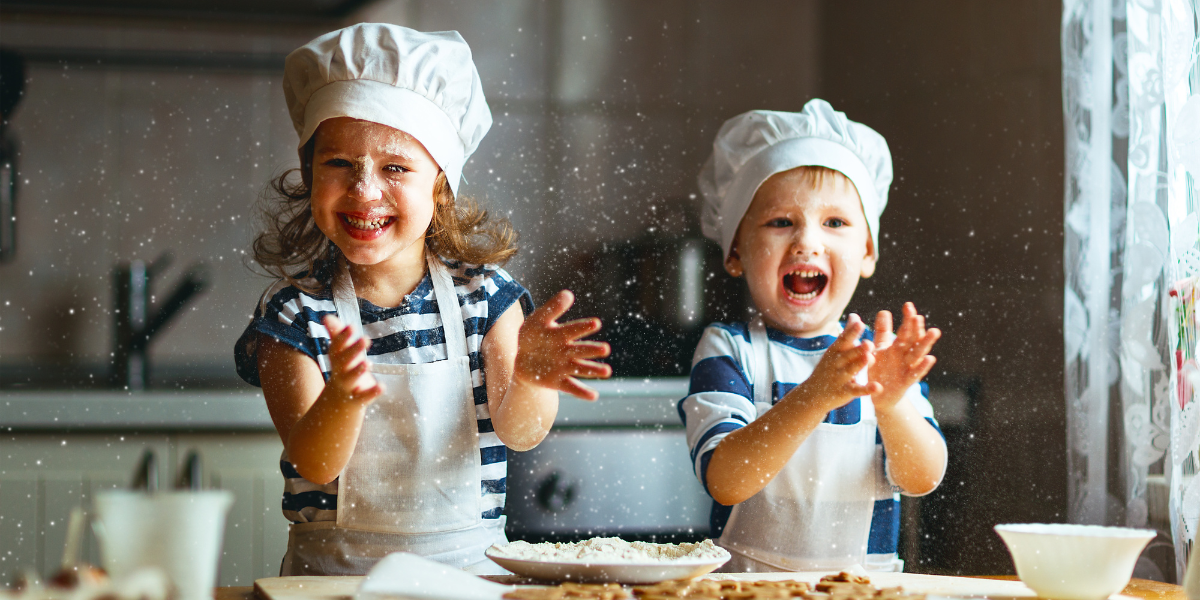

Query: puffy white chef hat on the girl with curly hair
<box><xmin>283</xmin><ymin>23</ymin><xmax>492</xmax><ymax>196</ymax></box>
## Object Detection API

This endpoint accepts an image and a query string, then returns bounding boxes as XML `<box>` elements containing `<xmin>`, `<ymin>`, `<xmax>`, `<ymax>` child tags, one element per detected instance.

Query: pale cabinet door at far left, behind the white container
<box><xmin>0</xmin><ymin>433</ymin><xmax>172</xmax><ymax>586</ymax></box>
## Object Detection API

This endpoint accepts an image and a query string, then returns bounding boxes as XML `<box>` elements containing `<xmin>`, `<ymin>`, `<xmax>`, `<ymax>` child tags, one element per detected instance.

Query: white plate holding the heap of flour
<box><xmin>484</xmin><ymin>548</ymin><xmax>730</xmax><ymax>583</ymax></box>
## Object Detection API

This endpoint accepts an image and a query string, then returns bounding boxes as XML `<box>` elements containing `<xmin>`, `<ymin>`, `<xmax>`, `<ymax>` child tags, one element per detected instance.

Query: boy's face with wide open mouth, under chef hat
<box><xmin>726</xmin><ymin>169</ymin><xmax>875</xmax><ymax>337</ymax></box>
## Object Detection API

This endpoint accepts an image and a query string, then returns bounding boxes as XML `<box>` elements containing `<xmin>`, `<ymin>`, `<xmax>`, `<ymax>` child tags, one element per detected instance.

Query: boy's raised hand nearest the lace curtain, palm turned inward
<box><xmin>866</xmin><ymin>302</ymin><xmax>942</xmax><ymax>409</ymax></box>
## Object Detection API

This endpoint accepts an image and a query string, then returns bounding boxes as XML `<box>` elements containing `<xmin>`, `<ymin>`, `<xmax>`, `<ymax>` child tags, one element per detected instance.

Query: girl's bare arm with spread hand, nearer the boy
<box><xmin>481</xmin><ymin>290</ymin><xmax>612</xmax><ymax>451</ymax></box>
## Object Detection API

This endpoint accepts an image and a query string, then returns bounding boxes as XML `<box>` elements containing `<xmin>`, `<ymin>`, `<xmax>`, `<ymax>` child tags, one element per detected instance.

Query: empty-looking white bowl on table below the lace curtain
<box><xmin>996</xmin><ymin>523</ymin><xmax>1156</xmax><ymax>600</ymax></box>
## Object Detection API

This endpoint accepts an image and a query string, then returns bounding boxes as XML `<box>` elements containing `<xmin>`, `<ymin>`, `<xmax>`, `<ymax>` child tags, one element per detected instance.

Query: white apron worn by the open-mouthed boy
<box><xmin>716</xmin><ymin>318</ymin><xmax>890</xmax><ymax>572</ymax></box>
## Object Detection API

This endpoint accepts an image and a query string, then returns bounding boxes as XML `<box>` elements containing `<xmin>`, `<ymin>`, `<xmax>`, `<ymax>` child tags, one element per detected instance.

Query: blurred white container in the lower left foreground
<box><xmin>95</xmin><ymin>490</ymin><xmax>233</xmax><ymax>600</ymax></box>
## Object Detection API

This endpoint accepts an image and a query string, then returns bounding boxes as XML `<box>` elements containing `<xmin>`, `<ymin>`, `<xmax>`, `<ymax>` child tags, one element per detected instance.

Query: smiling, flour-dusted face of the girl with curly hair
<box><xmin>312</xmin><ymin>116</ymin><xmax>440</xmax><ymax>270</ymax></box>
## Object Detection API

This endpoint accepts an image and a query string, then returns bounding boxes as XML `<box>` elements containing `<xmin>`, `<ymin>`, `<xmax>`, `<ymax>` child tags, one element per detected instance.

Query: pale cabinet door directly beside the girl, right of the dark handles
<box><xmin>172</xmin><ymin>431</ymin><xmax>288</xmax><ymax>586</ymax></box>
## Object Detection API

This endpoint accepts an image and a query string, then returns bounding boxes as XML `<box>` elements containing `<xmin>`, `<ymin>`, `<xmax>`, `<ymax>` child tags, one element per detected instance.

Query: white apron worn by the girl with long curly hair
<box><xmin>280</xmin><ymin>254</ymin><xmax>508</xmax><ymax>575</ymax></box>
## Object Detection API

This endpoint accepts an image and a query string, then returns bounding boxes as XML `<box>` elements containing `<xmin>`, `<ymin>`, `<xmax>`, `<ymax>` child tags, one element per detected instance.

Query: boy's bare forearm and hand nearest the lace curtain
<box><xmin>868</xmin><ymin>302</ymin><xmax>946</xmax><ymax>496</ymax></box>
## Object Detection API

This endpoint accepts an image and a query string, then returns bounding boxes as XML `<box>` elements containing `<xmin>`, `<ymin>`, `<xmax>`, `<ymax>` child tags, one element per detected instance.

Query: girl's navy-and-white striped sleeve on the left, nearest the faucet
<box><xmin>233</xmin><ymin>281</ymin><xmax>336</xmax><ymax>386</ymax></box>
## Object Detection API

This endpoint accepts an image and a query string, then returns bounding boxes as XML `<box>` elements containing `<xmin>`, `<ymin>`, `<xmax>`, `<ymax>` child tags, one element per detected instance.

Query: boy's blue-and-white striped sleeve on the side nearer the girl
<box><xmin>678</xmin><ymin>324</ymin><xmax>757</xmax><ymax>491</ymax></box>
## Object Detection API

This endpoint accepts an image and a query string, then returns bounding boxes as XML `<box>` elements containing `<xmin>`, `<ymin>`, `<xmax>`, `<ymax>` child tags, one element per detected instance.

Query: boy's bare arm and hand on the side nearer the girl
<box><xmin>707</xmin><ymin>314</ymin><xmax>878</xmax><ymax>506</ymax></box>
